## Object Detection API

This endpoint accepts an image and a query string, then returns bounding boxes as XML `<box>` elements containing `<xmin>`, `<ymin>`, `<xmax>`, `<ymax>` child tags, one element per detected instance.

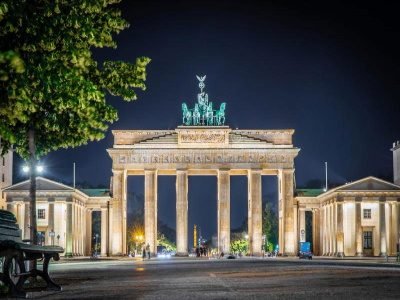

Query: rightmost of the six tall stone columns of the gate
<box><xmin>282</xmin><ymin>170</ymin><xmax>297</xmax><ymax>255</ymax></box>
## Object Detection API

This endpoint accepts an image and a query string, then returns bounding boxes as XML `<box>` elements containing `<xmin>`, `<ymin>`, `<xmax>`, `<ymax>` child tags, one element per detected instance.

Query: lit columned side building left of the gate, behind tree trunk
<box><xmin>3</xmin><ymin>177</ymin><xmax>110</xmax><ymax>256</ymax></box>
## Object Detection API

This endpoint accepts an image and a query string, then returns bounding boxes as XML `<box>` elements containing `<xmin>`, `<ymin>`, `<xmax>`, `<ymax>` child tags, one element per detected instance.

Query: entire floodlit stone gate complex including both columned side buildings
<box><xmin>0</xmin><ymin>76</ymin><xmax>400</xmax><ymax>256</ymax></box>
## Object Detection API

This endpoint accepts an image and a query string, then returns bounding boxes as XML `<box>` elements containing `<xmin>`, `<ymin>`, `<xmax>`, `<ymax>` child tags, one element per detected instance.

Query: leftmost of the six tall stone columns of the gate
<box><xmin>110</xmin><ymin>170</ymin><xmax>126</xmax><ymax>255</ymax></box>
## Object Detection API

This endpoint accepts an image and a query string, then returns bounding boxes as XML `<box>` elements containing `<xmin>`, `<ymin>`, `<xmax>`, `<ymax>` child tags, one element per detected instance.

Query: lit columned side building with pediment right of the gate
<box><xmin>295</xmin><ymin>177</ymin><xmax>400</xmax><ymax>256</ymax></box>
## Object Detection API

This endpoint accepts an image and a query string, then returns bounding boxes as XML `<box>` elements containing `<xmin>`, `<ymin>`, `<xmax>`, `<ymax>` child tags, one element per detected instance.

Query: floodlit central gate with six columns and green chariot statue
<box><xmin>107</xmin><ymin>76</ymin><xmax>300</xmax><ymax>256</ymax></box>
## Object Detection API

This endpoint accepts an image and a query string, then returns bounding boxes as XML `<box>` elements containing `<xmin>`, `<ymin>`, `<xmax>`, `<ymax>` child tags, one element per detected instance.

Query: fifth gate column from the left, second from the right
<box><xmin>248</xmin><ymin>170</ymin><xmax>262</xmax><ymax>256</ymax></box>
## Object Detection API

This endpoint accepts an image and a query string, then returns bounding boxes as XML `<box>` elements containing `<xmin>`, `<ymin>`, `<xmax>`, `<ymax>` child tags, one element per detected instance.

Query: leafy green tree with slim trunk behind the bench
<box><xmin>0</xmin><ymin>0</ymin><xmax>150</xmax><ymax>243</ymax></box>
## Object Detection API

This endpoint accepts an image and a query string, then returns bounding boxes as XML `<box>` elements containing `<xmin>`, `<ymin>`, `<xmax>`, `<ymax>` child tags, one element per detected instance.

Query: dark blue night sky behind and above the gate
<box><xmin>15</xmin><ymin>0</ymin><xmax>400</xmax><ymax>241</ymax></box>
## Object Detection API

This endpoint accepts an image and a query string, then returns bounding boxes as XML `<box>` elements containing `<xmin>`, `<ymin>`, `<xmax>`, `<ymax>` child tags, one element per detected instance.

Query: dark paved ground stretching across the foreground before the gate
<box><xmin>25</xmin><ymin>258</ymin><xmax>400</xmax><ymax>300</ymax></box>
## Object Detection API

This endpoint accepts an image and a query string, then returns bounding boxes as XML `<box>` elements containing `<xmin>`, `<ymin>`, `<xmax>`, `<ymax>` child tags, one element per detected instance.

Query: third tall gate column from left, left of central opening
<box><xmin>176</xmin><ymin>170</ymin><xmax>188</xmax><ymax>256</ymax></box>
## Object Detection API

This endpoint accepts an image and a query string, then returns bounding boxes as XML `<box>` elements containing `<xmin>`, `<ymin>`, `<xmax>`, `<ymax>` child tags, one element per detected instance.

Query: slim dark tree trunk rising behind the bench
<box><xmin>28</xmin><ymin>128</ymin><xmax>37</xmax><ymax>245</ymax></box>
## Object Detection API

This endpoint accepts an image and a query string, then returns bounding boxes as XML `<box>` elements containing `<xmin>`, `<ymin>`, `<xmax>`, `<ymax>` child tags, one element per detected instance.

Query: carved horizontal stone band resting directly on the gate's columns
<box><xmin>107</xmin><ymin>148</ymin><xmax>300</xmax><ymax>170</ymax></box>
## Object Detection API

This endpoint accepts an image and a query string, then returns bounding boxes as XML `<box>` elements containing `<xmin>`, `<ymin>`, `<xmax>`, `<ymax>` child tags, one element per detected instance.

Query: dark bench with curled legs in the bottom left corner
<box><xmin>0</xmin><ymin>210</ymin><xmax>64</xmax><ymax>298</ymax></box>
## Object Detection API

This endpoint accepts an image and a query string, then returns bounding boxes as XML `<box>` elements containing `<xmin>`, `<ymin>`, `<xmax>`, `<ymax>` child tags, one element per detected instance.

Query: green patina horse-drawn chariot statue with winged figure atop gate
<box><xmin>182</xmin><ymin>75</ymin><xmax>226</xmax><ymax>126</ymax></box>
